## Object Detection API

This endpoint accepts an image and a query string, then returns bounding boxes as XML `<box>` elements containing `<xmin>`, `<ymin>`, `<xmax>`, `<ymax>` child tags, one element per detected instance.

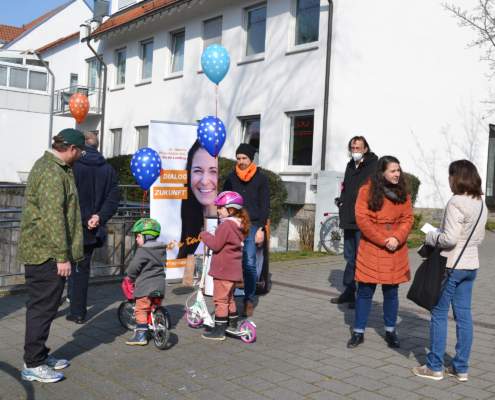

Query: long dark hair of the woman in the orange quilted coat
<box><xmin>368</xmin><ymin>156</ymin><xmax>409</xmax><ymax>211</ymax></box>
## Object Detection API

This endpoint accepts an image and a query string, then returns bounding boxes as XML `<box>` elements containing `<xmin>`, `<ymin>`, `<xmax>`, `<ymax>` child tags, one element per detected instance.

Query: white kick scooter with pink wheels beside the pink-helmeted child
<box><xmin>186</xmin><ymin>254</ymin><xmax>256</xmax><ymax>343</ymax></box>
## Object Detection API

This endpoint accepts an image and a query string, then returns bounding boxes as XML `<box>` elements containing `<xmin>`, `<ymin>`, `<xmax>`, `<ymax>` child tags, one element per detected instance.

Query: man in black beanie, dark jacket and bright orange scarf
<box><xmin>223</xmin><ymin>143</ymin><xmax>270</xmax><ymax>317</ymax></box>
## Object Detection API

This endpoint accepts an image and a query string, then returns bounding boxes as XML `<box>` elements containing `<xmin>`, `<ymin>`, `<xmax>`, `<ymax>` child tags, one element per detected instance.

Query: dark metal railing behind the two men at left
<box><xmin>0</xmin><ymin>185</ymin><xmax>149</xmax><ymax>286</ymax></box>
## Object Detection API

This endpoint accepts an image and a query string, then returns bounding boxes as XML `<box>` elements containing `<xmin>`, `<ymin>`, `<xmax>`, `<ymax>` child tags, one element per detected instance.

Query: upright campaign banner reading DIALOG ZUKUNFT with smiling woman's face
<box><xmin>149</xmin><ymin>121</ymin><xmax>218</xmax><ymax>281</ymax></box>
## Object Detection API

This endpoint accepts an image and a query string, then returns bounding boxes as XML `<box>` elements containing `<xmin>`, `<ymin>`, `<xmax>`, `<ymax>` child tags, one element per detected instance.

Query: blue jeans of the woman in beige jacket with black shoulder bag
<box><xmin>426</xmin><ymin>269</ymin><xmax>478</xmax><ymax>374</ymax></box>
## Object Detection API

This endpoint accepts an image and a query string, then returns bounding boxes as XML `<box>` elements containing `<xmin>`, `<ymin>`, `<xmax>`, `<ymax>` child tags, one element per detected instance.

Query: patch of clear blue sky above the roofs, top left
<box><xmin>0</xmin><ymin>0</ymin><xmax>112</xmax><ymax>28</ymax></box>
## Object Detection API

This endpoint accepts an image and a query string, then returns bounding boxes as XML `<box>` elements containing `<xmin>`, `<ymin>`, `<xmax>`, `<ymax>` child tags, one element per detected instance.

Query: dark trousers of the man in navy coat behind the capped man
<box><xmin>70</xmin><ymin>245</ymin><xmax>94</xmax><ymax>318</ymax></box>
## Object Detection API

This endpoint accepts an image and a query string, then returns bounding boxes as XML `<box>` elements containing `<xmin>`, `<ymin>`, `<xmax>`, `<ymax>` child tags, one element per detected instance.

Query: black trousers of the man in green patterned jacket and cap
<box><xmin>24</xmin><ymin>258</ymin><xmax>65</xmax><ymax>368</ymax></box>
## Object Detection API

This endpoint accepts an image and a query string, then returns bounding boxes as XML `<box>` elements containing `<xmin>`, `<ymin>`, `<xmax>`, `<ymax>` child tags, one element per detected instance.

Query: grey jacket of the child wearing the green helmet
<box><xmin>127</xmin><ymin>242</ymin><xmax>167</xmax><ymax>297</ymax></box>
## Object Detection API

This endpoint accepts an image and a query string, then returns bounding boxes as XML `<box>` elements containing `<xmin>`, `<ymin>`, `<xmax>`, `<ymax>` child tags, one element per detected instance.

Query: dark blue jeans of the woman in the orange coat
<box><xmin>354</xmin><ymin>282</ymin><xmax>399</xmax><ymax>333</ymax></box>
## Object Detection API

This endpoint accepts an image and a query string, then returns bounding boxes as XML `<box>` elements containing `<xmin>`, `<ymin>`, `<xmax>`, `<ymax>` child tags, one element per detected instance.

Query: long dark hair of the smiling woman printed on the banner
<box><xmin>177</xmin><ymin>140</ymin><xmax>204</xmax><ymax>258</ymax></box>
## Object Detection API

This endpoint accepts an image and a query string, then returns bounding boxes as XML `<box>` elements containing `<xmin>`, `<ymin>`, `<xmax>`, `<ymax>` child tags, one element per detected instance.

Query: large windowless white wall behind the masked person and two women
<box><xmin>327</xmin><ymin>0</ymin><xmax>493</xmax><ymax>207</ymax></box>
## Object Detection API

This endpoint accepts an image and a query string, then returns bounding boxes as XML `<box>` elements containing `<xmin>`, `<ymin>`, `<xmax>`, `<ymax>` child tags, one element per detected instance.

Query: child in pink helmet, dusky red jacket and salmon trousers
<box><xmin>201</xmin><ymin>192</ymin><xmax>251</xmax><ymax>340</ymax></box>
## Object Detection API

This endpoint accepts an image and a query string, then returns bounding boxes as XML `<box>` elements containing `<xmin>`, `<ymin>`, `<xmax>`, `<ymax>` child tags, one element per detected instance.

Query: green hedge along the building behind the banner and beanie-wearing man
<box><xmin>107</xmin><ymin>154</ymin><xmax>287</xmax><ymax>229</ymax></box>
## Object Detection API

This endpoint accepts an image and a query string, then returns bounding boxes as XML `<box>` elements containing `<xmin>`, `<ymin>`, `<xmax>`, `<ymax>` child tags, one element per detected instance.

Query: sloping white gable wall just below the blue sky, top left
<box><xmin>9</xmin><ymin>0</ymin><xmax>93</xmax><ymax>50</ymax></box>
